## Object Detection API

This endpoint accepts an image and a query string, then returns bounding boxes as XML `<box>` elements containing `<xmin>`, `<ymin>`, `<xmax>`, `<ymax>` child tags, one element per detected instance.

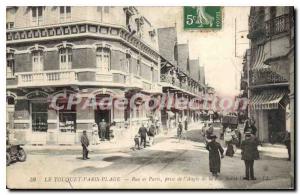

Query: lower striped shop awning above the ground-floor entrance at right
<box><xmin>250</xmin><ymin>91</ymin><xmax>289</xmax><ymax>110</ymax></box>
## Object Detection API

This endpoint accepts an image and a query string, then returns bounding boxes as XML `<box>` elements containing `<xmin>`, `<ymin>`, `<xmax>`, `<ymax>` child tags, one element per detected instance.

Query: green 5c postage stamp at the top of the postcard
<box><xmin>184</xmin><ymin>6</ymin><xmax>222</xmax><ymax>30</ymax></box>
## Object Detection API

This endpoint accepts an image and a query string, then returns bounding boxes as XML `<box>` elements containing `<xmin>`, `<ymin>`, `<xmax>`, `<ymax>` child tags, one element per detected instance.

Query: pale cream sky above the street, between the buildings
<box><xmin>138</xmin><ymin>7</ymin><xmax>250</xmax><ymax>96</ymax></box>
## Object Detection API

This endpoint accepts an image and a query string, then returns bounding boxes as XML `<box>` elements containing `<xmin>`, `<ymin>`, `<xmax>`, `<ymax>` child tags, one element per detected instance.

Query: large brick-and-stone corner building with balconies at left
<box><xmin>6</xmin><ymin>6</ymin><xmax>162</xmax><ymax>144</ymax></box>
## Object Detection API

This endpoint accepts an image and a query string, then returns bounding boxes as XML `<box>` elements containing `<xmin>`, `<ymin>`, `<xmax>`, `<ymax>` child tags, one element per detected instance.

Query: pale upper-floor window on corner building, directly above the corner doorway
<box><xmin>96</xmin><ymin>47</ymin><xmax>110</xmax><ymax>72</ymax></box>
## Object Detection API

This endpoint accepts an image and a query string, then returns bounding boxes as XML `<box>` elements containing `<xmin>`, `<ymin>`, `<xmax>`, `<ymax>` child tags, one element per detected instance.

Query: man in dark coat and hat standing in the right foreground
<box><xmin>241</xmin><ymin>131</ymin><xmax>259</xmax><ymax>180</ymax></box>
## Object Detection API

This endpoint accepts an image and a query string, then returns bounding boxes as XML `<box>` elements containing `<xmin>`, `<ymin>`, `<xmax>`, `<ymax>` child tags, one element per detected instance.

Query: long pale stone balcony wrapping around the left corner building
<box><xmin>16</xmin><ymin>69</ymin><xmax>144</xmax><ymax>89</ymax></box>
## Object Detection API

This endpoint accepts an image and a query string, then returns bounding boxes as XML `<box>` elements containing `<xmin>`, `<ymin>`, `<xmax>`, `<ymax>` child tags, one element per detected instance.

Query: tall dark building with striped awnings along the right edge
<box><xmin>246</xmin><ymin>7</ymin><xmax>294</xmax><ymax>143</ymax></box>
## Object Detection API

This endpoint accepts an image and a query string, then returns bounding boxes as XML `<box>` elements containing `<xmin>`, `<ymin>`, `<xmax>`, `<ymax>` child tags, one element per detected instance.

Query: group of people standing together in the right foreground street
<box><xmin>203</xmin><ymin>121</ymin><xmax>259</xmax><ymax>180</ymax></box>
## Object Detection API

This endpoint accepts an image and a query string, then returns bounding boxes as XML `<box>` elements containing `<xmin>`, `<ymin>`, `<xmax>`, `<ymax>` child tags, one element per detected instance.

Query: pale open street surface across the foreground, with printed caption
<box><xmin>7</xmin><ymin>130</ymin><xmax>291</xmax><ymax>189</ymax></box>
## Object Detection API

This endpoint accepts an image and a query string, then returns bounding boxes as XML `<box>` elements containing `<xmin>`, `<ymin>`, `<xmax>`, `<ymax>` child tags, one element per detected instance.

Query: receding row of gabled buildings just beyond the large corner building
<box><xmin>157</xmin><ymin>27</ymin><xmax>206</xmax><ymax>129</ymax></box>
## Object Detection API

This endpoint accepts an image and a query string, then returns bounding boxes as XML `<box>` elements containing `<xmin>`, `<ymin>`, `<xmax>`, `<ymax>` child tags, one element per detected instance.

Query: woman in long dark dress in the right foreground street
<box><xmin>206</xmin><ymin>135</ymin><xmax>224</xmax><ymax>176</ymax></box>
